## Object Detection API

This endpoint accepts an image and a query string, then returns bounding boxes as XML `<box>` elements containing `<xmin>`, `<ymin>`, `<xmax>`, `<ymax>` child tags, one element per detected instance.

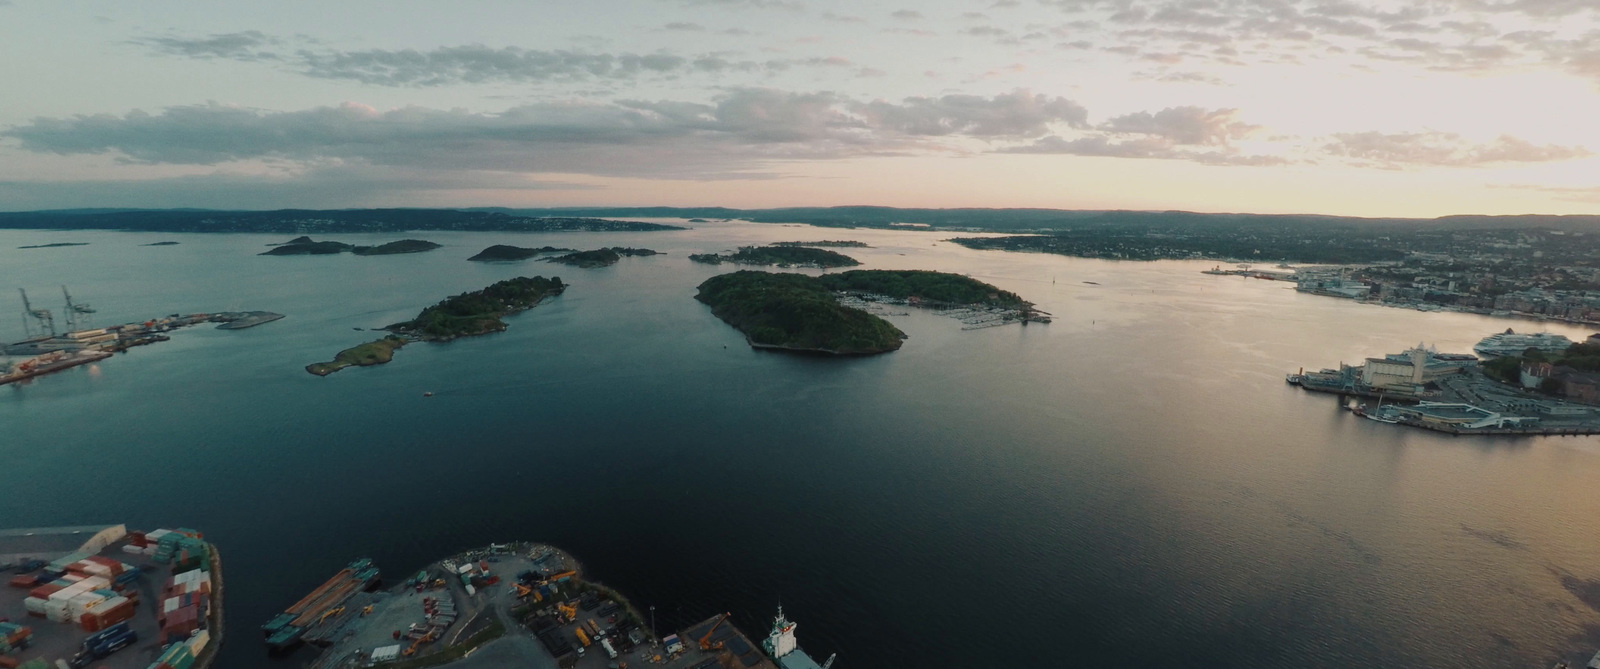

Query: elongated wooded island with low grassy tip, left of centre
<box><xmin>306</xmin><ymin>277</ymin><xmax>566</xmax><ymax>376</ymax></box>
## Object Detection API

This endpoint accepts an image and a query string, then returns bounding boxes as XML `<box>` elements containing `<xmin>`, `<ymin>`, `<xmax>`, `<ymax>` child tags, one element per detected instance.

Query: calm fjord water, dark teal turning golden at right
<box><xmin>0</xmin><ymin>224</ymin><xmax>1600</xmax><ymax>669</ymax></box>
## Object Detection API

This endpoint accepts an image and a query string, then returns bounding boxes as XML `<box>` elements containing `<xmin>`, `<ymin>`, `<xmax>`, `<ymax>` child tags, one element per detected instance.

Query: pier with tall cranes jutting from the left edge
<box><xmin>0</xmin><ymin>286</ymin><xmax>283</xmax><ymax>386</ymax></box>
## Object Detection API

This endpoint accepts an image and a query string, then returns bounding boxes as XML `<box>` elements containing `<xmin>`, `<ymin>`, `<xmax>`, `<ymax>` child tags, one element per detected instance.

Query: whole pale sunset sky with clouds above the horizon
<box><xmin>0</xmin><ymin>0</ymin><xmax>1600</xmax><ymax>216</ymax></box>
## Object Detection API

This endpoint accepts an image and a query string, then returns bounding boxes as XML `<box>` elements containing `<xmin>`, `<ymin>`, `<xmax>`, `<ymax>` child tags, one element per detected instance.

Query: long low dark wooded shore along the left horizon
<box><xmin>0</xmin><ymin>210</ymin><xmax>685</xmax><ymax>234</ymax></box>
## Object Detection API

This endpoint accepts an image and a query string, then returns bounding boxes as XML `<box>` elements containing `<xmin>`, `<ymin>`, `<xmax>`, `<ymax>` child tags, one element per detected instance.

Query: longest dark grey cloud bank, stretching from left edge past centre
<box><xmin>0</xmin><ymin>88</ymin><xmax>1086</xmax><ymax>179</ymax></box>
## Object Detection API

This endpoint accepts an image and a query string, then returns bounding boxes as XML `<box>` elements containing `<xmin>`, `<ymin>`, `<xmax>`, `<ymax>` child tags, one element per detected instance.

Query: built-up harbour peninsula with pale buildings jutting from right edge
<box><xmin>1286</xmin><ymin>338</ymin><xmax>1600</xmax><ymax>435</ymax></box>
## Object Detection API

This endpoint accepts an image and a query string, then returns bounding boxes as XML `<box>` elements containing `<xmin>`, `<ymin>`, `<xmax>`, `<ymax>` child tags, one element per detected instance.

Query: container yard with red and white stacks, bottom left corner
<box><xmin>0</xmin><ymin>525</ymin><xmax>222</xmax><ymax>669</ymax></box>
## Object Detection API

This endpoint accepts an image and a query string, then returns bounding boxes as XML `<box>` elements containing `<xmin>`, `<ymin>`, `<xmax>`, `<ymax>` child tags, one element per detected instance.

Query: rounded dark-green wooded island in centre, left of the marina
<box><xmin>694</xmin><ymin>270</ymin><xmax>906</xmax><ymax>355</ymax></box>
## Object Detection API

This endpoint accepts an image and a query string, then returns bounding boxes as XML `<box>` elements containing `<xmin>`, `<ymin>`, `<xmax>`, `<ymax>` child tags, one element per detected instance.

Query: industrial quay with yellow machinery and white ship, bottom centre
<box><xmin>281</xmin><ymin>543</ymin><xmax>834</xmax><ymax>669</ymax></box>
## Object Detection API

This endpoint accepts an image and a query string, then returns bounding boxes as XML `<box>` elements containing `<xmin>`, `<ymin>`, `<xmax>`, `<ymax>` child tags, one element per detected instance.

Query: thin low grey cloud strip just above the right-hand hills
<box><xmin>1323</xmin><ymin>131</ymin><xmax>1594</xmax><ymax>170</ymax></box>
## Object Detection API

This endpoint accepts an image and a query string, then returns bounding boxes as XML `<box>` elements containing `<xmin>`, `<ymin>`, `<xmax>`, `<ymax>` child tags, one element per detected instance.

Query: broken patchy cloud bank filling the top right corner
<box><xmin>1040</xmin><ymin>0</ymin><xmax>1600</xmax><ymax>82</ymax></box>
